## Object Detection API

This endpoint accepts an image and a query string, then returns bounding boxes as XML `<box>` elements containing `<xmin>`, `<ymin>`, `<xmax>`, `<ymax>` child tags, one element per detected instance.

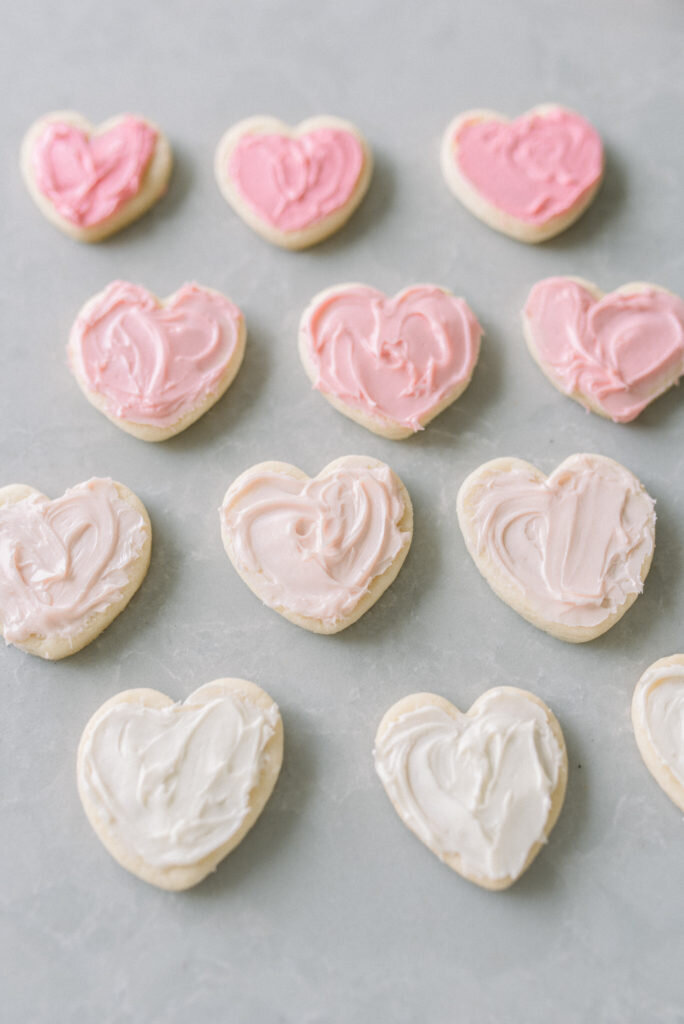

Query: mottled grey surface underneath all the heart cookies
<box><xmin>0</xmin><ymin>0</ymin><xmax>684</xmax><ymax>1024</ymax></box>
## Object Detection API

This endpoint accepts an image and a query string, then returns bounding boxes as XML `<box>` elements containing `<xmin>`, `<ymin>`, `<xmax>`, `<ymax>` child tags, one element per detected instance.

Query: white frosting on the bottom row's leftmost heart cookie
<box><xmin>81</xmin><ymin>684</ymin><xmax>279</xmax><ymax>867</ymax></box>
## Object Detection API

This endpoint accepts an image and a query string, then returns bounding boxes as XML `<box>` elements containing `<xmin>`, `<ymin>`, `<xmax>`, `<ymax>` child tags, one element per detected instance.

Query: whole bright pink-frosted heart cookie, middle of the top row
<box><xmin>214</xmin><ymin>116</ymin><xmax>373</xmax><ymax>249</ymax></box>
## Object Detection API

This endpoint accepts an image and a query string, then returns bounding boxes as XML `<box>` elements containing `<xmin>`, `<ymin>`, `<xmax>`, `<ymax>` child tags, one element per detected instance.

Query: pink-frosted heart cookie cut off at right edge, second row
<box><xmin>524</xmin><ymin>278</ymin><xmax>684</xmax><ymax>423</ymax></box>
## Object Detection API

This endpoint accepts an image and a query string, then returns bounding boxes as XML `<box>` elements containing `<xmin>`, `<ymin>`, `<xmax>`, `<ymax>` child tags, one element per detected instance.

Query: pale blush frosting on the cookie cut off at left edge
<box><xmin>0</xmin><ymin>477</ymin><xmax>147</xmax><ymax>643</ymax></box>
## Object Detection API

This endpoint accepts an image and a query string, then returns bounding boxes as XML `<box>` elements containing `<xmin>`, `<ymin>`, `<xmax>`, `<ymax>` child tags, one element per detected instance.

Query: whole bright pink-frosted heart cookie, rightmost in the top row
<box><xmin>441</xmin><ymin>103</ymin><xmax>603</xmax><ymax>243</ymax></box>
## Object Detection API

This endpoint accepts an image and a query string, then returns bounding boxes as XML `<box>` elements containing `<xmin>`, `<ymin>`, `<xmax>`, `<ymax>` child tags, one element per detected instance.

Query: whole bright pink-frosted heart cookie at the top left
<box><xmin>22</xmin><ymin>111</ymin><xmax>172</xmax><ymax>242</ymax></box>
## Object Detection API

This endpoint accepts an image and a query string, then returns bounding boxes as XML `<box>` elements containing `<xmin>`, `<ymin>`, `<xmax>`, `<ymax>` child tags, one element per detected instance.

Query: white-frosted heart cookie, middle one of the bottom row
<box><xmin>374</xmin><ymin>686</ymin><xmax>567</xmax><ymax>889</ymax></box>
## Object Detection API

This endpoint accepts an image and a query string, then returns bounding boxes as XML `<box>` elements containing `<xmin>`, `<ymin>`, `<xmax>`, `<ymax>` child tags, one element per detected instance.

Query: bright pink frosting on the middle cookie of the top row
<box><xmin>227</xmin><ymin>128</ymin><xmax>365</xmax><ymax>231</ymax></box>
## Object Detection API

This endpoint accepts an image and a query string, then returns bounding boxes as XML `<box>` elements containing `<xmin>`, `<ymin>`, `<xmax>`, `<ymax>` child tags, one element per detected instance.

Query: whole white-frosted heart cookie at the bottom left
<box><xmin>77</xmin><ymin>679</ymin><xmax>283</xmax><ymax>890</ymax></box>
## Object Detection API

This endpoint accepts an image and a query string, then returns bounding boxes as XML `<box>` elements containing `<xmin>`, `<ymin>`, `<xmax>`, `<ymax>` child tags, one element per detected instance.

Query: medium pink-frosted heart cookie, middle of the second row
<box><xmin>299</xmin><ymin>285</ymin><xmax>482</xmax><ymax>439</ymax></box>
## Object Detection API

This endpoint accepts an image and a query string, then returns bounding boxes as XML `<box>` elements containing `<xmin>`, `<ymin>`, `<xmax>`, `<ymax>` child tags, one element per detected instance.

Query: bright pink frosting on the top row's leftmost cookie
<box><xmin>33</xmin><ymin>116</ymin><xmax>157</xmax><ymax>227</ymax></box>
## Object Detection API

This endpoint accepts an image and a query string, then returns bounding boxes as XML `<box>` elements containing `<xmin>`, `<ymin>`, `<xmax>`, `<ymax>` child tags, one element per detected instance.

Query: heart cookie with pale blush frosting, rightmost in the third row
<box><xmin>458</xmin><ymin>455</ymin><xmax>655</xmax><ymax>643</ymax></box>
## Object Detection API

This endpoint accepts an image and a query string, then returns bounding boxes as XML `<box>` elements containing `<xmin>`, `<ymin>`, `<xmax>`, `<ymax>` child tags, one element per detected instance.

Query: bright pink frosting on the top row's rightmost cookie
<box><xmin>454</xmin><ymin>109</ymin><xmax>603</xmax><ymax>224</ymax></box>
